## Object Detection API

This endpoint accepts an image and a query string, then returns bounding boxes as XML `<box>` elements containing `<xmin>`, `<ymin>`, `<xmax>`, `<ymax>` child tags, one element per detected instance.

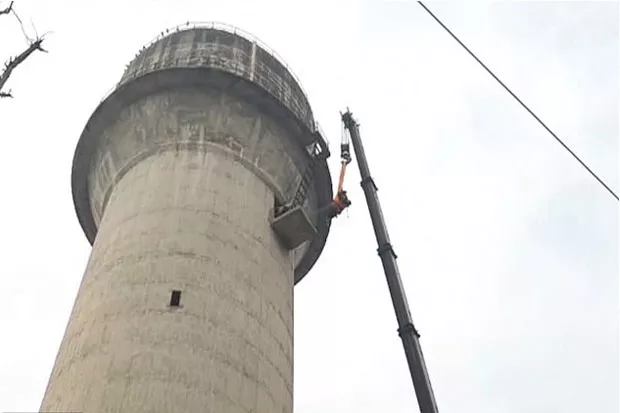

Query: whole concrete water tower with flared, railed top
<box><xmin>41</xmin><ymin>24</ymin><xmax>332</xmax><ymax>413</ymax></box>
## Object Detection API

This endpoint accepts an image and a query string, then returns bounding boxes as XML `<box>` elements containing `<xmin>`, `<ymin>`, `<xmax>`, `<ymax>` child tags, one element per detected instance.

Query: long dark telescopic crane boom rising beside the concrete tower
<box><xmin>342</xmin><ymin>110</ymin><xmax>438</xmax><ymax>413</ymax></box>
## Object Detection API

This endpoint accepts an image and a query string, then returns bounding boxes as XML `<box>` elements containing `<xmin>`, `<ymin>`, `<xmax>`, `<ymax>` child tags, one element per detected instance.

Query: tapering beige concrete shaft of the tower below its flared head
<box><xmin>42</xmin><ymin>146</ymin><xmax>293</xmax><ymax>412</ymax></box>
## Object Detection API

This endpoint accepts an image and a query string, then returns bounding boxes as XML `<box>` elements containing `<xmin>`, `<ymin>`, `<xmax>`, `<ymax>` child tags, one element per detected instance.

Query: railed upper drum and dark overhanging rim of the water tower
<box><xmin>72</xmin><ymin>22</ymin><xmax>333</xmax><ymax>282</ymax></box>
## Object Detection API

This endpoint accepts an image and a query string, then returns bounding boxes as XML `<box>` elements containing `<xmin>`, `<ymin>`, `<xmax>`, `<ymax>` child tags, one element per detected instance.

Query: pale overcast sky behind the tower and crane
<box><xmin>0</xmin><ymin>0</ymin><xmax>620</xmax><ymax>413</ymax></box>
